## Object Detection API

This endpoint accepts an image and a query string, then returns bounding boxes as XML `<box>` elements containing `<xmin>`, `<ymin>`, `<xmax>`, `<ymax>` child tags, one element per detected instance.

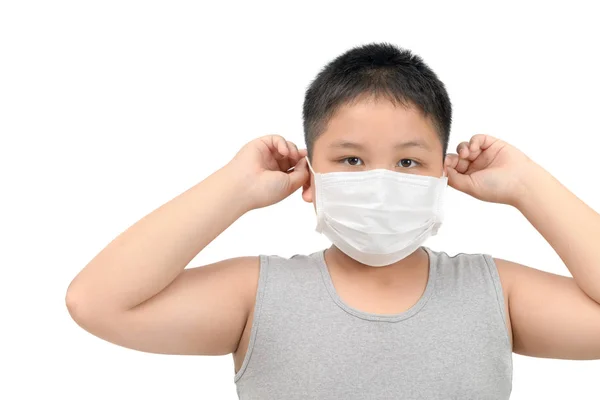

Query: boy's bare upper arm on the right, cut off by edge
<box><xmin>494</xmin><ymin>259</ymin><xmax>600</xmax><ymax>360</ymax></box>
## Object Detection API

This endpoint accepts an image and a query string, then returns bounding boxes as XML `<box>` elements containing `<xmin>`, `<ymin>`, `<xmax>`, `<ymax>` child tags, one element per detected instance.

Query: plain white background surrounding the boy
<box><xmin>0</xmin><ymin>1</ymin><xmax>600</xmax><ymax>399</ymax></box>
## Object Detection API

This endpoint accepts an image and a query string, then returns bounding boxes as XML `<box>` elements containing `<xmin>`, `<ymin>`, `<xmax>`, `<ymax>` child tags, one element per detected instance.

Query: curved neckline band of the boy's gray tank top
<box><xmin>316</xmin><ymin>246</ymin><xmax>437</xmax><ymax>322</ymax></box>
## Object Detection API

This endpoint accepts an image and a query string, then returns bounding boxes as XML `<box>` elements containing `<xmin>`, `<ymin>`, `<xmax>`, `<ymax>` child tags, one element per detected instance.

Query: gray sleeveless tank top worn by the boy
<box><xmin>234</xmin><ymin>247</ymin><xmax>512</xmax><ymax>400</ymax></box>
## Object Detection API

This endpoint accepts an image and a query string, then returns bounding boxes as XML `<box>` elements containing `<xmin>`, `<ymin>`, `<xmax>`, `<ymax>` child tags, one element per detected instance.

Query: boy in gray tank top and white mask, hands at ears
<box><xmin>66</xmin><ymin>43</ymin><xmax>600</xmax><ymax>399</ymax></box>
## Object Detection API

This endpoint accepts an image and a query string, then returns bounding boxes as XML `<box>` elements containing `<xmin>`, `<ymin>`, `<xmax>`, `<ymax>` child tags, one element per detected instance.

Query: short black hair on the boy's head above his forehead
<box><xmin>303</xmin><ymin>42</ymin><xmax>452</xmax><ymax>160</ymax></box>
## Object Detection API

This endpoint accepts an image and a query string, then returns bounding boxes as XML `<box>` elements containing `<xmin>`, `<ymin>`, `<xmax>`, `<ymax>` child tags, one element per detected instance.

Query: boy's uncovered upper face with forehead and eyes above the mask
<box><xmin>302</xmin><ymin>99</ymin><xmax>443</xmax><ymax>203</ymax></box>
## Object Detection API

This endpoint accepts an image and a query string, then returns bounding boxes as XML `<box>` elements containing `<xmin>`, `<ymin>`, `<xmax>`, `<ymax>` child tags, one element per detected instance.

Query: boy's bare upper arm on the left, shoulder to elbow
<box><xmin>68</xmin><ymin>257</ymin><xmax>259</xmax><ymax>355</ymax></box>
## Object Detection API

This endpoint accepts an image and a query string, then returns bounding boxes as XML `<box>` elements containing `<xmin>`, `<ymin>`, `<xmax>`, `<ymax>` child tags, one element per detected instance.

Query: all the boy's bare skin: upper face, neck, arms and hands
<box><xmin>66</xmin><ymin>94</ymin><xmax>600</xmax><ymax>378</ymax></box>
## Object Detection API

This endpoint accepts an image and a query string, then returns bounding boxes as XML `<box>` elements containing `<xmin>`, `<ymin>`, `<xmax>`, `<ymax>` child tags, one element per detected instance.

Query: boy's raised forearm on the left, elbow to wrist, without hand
<box><xmin>67</xmin><ymin>163</ymin><xmax>250</xmax><ymax>312</ymax></box>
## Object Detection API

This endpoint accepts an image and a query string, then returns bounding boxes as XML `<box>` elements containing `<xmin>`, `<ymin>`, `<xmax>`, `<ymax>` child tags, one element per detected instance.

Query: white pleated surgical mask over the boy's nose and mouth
<box><xmin>306</xmin><ymin>157</ymin><xmax>448</xmax><ymax>267</ymax></box>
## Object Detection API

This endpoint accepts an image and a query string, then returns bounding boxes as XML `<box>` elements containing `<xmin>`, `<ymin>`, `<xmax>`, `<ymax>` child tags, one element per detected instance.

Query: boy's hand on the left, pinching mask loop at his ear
<box><xmin>227</xmin><ymin>135</ymin><xmax>310</xmax><ymax>209</ymax></box>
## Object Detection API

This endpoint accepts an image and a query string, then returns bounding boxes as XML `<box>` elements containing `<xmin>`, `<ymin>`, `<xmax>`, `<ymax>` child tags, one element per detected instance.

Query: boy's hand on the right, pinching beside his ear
<box><xmin>444</xmin><ymin>135</ymin><xmax>540</xmax><ymax>207</ymax></box>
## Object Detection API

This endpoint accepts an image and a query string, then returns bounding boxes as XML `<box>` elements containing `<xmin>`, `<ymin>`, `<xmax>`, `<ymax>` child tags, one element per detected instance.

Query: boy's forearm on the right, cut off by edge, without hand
<box><xmin>515</xmin><ymin>165</ymin><xmax>600</xmax><ymax>303</ymax></box>
